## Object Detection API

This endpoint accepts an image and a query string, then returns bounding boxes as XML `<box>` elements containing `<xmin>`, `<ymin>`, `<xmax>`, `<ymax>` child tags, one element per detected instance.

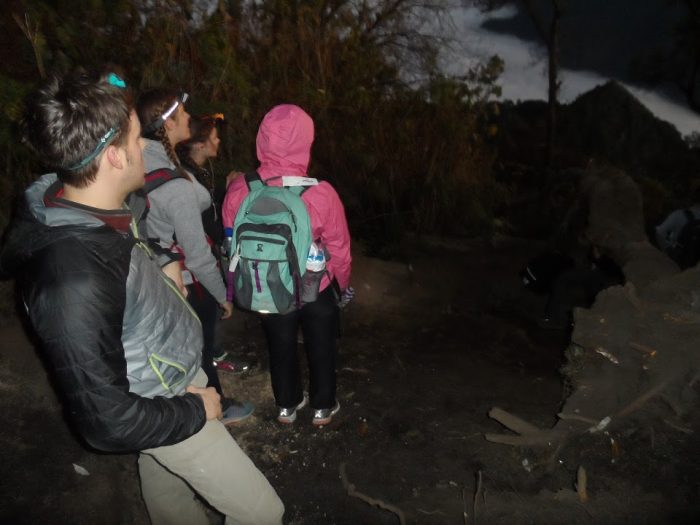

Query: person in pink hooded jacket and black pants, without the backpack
<box><xmin>222</xmin><ymin>104</ymin><xmax>351</xmax><ymax>425</ymax></box>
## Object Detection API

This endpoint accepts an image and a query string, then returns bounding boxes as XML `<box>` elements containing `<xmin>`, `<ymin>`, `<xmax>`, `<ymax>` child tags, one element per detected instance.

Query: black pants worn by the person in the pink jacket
<box><xmin>261</xmin><ymin>286</ymin><xmax>339</xmax><ymax>409</ymax></box>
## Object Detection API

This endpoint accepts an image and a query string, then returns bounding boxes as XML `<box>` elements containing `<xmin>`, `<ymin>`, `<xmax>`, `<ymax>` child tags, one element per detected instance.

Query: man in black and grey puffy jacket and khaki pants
<box><xmin>0</xmin><ymin>73</ymin><xmax>284</xmax><ymax>524</ymax></box>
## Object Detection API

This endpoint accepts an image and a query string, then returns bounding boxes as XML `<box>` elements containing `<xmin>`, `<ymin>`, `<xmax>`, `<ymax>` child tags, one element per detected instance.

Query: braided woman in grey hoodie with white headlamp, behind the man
<box><xmin>136</xmin><ymin>89</ymin><xmax>253</xmax><ymax>424</ymax></box>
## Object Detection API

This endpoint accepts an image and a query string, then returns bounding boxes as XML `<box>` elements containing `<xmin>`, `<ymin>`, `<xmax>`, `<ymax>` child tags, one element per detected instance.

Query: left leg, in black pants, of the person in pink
<box><xmin>262</xmin><ymin>312</ymin><xmax>304</xmax><ymax>408</ymax></box>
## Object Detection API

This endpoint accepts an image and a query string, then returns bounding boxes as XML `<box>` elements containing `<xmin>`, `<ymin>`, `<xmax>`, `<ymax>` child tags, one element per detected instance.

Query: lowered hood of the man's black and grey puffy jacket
<box><xmin>0</xmin><ymin>173</ymin><xmax>131</xmax><ymax>279</ymax></box>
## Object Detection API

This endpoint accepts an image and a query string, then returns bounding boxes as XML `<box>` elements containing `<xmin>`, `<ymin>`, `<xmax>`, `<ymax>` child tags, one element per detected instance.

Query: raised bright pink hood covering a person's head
<box><xmin>256</xmin><ymin>104</ymin><xmax>314</xmax><ymax>178</ymax></box>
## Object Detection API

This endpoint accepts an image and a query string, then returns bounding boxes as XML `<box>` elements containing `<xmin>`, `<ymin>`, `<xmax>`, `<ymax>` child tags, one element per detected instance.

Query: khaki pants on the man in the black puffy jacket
<box><xmin>139</xmin><ymin>370</ymin><xmax>284</xmax><ymax>525</ymax></box>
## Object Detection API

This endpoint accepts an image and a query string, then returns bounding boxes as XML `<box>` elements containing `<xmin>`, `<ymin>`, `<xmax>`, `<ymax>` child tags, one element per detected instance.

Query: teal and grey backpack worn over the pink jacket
<box><xmin>229</xmin><ymin>173</ymin><xmax>312</xmax><ymax>314</ymax></box>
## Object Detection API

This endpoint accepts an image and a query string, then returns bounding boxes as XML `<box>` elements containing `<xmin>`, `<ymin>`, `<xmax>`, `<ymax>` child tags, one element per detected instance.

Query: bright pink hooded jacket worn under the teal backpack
<box><xmin>222</xmin><ymin>104</ymin><xmax>352</xmax><ymax>299</ymax></box>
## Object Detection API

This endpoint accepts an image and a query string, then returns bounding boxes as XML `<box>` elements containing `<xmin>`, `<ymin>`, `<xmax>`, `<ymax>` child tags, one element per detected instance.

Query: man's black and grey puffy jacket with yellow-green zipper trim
<box><xmin>0</xmin><ymin>175</ymin><xmax>206</xmax><ymax>452</ymax></box>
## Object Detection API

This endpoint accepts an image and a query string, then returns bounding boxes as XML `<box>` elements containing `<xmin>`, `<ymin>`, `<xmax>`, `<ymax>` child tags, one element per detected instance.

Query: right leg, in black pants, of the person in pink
<box><xmin>301</xmin><ymin>287</ymin><xmax>339</xmax><ymax>409</ymax></box>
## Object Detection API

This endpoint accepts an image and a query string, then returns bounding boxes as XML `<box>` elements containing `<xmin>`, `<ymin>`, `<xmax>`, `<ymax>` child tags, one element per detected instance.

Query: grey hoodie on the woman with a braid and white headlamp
<box><xmin>143</xmin><ymin>139</ymin><xmax>226</xmax><ymax>304</ymax></box>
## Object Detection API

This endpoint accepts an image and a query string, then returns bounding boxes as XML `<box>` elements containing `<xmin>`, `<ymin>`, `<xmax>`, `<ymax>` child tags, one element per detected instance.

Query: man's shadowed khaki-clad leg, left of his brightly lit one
<box><xmin>139</xmin><ymin>454</ymin><xmax>209</xmax><ymax>525</ymax></box>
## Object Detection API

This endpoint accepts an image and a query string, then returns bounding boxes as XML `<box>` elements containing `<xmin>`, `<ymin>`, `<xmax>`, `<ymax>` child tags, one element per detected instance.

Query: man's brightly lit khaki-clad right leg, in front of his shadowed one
<box><xmin>143</xmin><ymin>421</ymin><xmax>284</xmax><ymax>525</ymax></box>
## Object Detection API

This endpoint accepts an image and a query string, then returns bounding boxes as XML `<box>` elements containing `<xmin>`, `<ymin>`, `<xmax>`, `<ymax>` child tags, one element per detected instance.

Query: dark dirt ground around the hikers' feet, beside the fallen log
<box><xmin>0</xmin><ymin>239</ymin><xmax>700</xmax><ymax>525</ymax></box>
